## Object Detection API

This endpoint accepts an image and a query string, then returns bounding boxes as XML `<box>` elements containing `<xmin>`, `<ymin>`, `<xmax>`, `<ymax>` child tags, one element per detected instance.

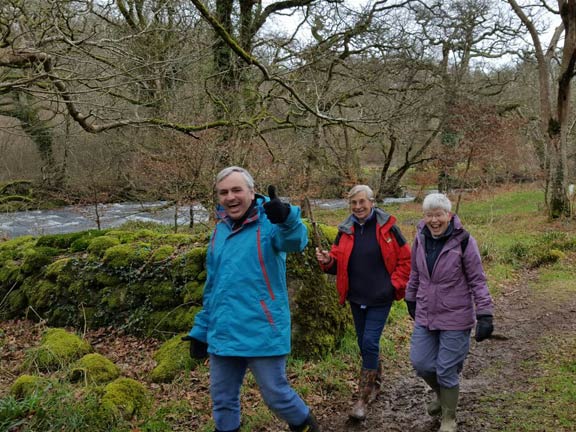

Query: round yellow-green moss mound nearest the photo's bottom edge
<box><xmin>101</xmin><ymin>378</ymin><xmax>151</xmax><ymax>419</ymax></box>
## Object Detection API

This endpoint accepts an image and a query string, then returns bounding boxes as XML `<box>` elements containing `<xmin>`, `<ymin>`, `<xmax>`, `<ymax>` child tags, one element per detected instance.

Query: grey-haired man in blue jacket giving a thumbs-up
<box><xmin>185</xmin><ymin>166</ymin><xmax>320</xmax><ymax>432</ymax></box>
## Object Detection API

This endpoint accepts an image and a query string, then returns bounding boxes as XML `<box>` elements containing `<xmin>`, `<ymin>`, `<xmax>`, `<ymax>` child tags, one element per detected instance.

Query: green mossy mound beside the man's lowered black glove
<box><xmin>149</xmin><ymin>333</ymin><xmax>197</xmax><ymax>383</ymax></box>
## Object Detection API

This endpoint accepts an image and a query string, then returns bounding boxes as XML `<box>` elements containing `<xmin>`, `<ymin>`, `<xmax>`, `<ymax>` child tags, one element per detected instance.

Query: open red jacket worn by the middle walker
<box><xmin>320</xmin><ymin>208</ymin><xmax>410</xmax><ymax>304</ymax></box>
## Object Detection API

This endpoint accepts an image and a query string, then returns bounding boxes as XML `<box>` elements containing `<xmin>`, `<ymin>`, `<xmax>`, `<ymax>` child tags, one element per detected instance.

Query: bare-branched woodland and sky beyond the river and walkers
<box><xmin>0</xmin><ymin>0</ymin><xmax>576</xmax><ymax>217</ymax></box>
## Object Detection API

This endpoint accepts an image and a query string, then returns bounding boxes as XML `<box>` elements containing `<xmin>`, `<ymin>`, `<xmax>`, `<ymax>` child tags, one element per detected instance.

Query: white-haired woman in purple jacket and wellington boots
<box><xmin>405</xmin><ymin>193</ymin><xmax>493</xmax><ymax>432</ymax></box>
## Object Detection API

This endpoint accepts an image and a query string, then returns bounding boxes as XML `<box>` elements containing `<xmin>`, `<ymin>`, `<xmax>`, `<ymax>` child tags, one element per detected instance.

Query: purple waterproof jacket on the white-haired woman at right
<box><xmin>405</xmin><ymin>215</ymin><xmax>494</xmax><ymax>330</ymax></box>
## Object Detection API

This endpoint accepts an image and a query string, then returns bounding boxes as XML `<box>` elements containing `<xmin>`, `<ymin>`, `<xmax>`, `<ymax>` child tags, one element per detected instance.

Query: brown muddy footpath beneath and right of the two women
<box><xmin>320</xmin><ymin>270</ymin><xmax>576</xmax><ymax>432</ymax></box>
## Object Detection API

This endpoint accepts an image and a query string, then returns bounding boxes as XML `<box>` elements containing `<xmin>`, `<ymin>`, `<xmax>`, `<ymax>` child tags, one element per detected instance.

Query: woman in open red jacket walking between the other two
<box><xmin>316</xmin><ymin>185</ymin><xmax>410</xmax><ymax>420</ymax></box>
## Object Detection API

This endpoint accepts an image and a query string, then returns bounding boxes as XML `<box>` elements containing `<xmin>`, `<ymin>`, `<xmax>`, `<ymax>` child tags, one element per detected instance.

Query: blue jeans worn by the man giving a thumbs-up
<box><xmin>210</xmin><ymin>354</ymin><xmax>310</xmax><ymax>431</ymax></box>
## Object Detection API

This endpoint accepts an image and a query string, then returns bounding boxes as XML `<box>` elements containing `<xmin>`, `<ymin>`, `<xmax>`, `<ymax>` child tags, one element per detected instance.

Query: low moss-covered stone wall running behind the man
<box><xmin>0</xmin><ymin>223</ymin><xmax>349</xmax><ymax>357</ymax></box>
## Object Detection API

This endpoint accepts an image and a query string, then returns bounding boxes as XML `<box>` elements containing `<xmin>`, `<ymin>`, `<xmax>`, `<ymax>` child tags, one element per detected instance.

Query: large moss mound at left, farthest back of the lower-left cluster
<box><xmin>24</xmin><ymin>328</ymin><xmax>92</xmax><ymax>370</ymax></box>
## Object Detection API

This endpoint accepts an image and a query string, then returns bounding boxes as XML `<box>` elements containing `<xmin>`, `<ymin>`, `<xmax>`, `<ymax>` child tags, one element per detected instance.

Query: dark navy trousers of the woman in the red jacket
<box><xmin>350</xmin><ymin>303</ymin><xmax>392</xmax><ymax>370</ymax></box>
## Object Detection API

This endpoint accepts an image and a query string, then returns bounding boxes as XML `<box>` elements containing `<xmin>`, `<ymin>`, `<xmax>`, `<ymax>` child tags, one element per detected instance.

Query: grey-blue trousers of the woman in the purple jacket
<box><xmin>410</xmin><ymin>325</ymin><xmax>471</xmax><ymax>388</ymax></box>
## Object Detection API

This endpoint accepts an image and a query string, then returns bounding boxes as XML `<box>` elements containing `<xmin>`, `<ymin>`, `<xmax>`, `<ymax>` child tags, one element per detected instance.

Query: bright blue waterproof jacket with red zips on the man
<box><xmin>188</xmin><ymin>195</ymin><xmax>308</xmax><ymax>357</ymax></box>
